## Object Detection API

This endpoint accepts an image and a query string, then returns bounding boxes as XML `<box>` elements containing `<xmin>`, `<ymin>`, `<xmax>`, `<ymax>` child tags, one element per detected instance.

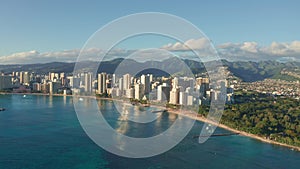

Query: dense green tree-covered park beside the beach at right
<box><xmin>199</xmin><ymin>91</ymin><xmax>300</xmax><ymax>146</ymax></box>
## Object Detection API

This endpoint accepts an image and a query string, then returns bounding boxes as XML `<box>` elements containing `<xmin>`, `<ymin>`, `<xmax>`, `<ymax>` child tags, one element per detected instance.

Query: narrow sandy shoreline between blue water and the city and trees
<box><xmin>0</xmin><ymin>92</ymin><xmax>300</xmax><ymax>152</ymax></box>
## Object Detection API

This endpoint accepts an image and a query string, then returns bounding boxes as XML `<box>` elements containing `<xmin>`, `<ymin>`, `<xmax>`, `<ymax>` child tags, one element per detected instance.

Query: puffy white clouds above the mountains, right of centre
<box><xmin>162</xmin><ymin>38</ymin><xmax>300</xmax><ymax>61</ymax></box>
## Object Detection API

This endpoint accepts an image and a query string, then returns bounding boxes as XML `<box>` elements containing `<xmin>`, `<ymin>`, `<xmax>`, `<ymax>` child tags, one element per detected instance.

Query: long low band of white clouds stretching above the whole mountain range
<box><xmin>0</xmin><ymin>38</ymin><xmax>300</xmax><ymax>64</ymax></box>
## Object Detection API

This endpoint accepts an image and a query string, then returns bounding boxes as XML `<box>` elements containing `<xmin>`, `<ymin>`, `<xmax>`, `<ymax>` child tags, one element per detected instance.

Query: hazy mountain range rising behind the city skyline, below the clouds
<box><xmin>0</xmin><ymin>58</ymin><xmax>300</xmax><ymax>82</ymax></box>
